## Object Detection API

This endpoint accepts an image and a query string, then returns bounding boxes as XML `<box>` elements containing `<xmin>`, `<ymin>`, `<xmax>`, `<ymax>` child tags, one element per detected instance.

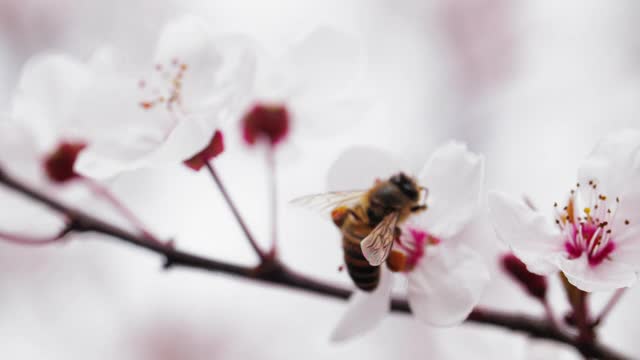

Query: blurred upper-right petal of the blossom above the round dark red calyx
<box><xmin>283</xmin><ymin>28</ymin><xmax>364</xmax><ymax>98</ymax></box>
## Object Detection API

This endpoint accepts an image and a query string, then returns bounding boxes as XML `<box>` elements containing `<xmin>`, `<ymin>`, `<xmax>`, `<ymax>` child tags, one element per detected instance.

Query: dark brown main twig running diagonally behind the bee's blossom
<box><xmin>0</xmin><ymin>169</ymin><xmax>628</xmax><ymax>360</ymax></box>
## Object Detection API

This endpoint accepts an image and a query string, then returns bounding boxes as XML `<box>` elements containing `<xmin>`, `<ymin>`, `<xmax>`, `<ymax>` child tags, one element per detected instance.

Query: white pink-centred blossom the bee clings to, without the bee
<box><xmin>329</xmin><ymin>142</ymin><xmax>489</xmax><ymax>341</ymax></box>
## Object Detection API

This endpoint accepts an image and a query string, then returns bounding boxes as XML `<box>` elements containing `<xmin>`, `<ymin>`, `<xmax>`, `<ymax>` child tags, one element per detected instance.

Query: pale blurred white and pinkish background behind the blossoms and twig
<box><xmin>0</xmin><ymin>0</ymin><xmax>640</xmax><ymax>360</ymax></box>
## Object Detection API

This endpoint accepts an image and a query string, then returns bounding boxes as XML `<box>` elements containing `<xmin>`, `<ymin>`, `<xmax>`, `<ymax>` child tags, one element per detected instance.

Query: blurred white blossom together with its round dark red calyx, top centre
<box><xmin>242</xmin><ymin>27</ymin><xmax>364</xmax><ymax>145</ymax></box>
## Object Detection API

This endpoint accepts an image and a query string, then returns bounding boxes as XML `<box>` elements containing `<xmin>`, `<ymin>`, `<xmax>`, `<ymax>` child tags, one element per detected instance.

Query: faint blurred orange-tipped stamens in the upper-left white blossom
<box><xmin>138</xmin><ymin>59</ymin><xmax>188</xmax><ymax>111</ymax></box>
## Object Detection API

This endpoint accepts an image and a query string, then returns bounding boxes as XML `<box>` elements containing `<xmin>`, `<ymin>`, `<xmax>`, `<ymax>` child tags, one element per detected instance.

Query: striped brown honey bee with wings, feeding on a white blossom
<box><xmin>292</xmin><ymin>172</ymin><xmax>428</xmax><ymax>292</ymax></box>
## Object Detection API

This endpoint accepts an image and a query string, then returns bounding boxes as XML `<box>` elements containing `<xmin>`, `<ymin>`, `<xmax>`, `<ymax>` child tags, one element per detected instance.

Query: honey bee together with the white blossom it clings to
<box><xmin>294</xmin><ymin>142</ymin><xmax>489</xmax><ymax>341</ymax></box>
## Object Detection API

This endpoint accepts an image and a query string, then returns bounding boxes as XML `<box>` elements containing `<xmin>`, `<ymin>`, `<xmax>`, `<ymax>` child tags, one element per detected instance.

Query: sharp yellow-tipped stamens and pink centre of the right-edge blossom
<box><xmin>553</xmin><ymin>180</ymin><xmax>629</xmax><ymax>266</ymax></box>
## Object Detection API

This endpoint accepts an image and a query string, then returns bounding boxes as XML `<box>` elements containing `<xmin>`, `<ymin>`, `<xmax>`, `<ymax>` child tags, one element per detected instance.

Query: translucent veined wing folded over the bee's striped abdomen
<box><xmin>360</xmin><ymin>212</ymin><xmax>399</xmax><ymax>266</ymax></box>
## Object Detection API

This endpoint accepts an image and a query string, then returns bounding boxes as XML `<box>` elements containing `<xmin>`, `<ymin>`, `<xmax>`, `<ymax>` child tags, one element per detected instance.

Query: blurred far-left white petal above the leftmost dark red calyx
<box><xmin>11</xmin><ymin>54</ymin><xmax>90</xmax><ymax>148</ymax></box>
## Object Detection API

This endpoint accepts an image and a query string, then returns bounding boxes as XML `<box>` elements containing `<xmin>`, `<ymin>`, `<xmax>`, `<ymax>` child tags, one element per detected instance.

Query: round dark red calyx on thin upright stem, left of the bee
<box><xmin>242</xmin><ymin>104</ymin><xmax>289</xmax><ymax>146</ymax></box>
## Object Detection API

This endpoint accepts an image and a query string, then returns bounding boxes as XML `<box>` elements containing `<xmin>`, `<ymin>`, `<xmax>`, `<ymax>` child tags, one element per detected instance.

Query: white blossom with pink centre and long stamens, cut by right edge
<box><xmin>489</xmin><ymin>130</ymin><xmax>640</xmax><ymax>292</ymax></box>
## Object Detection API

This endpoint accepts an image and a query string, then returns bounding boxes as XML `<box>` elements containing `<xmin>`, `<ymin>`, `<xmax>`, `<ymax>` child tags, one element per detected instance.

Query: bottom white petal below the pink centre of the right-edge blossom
<box><xmin>558</xmin><ymin>255</ymin><xmax>637</xmax><ymax>292</ymax></box>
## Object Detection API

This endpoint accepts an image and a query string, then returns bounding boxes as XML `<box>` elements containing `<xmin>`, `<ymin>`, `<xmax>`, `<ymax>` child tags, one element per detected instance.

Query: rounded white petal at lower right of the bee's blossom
<box><xmin>409</xmin><ymin>246</ymin><xmax>489</xmax><ymax>326</ymax></box>
